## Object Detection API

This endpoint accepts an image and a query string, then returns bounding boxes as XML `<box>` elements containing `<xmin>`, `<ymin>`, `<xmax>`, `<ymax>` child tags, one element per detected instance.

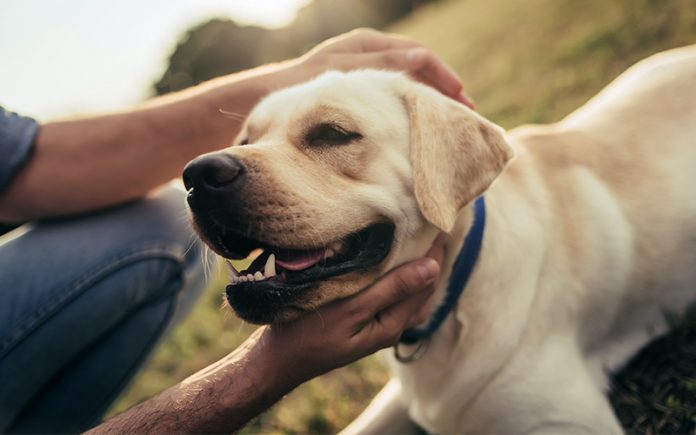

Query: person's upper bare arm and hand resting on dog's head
<box><xmin>0</xmin><ymin>29</ymin><xmax>471</xmax><ymax>221</ymax></box>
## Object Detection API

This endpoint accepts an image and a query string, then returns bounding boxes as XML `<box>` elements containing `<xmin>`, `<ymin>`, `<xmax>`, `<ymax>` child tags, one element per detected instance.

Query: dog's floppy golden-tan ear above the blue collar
<box><xmin>404</xmin><ymin>84</ymin><xmax>514</xmax><ymax>232</ymax></box>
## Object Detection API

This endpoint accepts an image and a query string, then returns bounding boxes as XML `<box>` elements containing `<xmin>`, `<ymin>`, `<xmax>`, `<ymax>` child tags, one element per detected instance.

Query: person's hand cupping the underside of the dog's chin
<box><xmin>247</xmin><ymin>238</ymin><xmax>444</xmax><ymax>392</ymax></box>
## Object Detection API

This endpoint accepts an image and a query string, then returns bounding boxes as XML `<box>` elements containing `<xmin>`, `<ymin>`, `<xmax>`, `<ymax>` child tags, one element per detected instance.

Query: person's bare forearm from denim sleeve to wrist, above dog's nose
<box><xmin>0</xmin><ymin>62</ymin><xmax>296</xmax><ymax>220</ymax></box>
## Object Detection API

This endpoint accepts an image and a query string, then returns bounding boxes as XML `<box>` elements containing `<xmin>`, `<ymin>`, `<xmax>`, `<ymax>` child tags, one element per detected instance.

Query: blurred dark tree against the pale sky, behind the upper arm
<box><xmin>154</xmin><ymin>0</ymin><xmax>428</xmax><ymax>95</ymax></box>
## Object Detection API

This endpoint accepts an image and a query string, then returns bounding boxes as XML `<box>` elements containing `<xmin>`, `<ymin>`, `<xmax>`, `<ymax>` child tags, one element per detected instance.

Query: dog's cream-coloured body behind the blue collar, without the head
<box><xmin>388</xmin><ymin>47</ymin><xmax>696</xmax><ymax>433</ymax></box>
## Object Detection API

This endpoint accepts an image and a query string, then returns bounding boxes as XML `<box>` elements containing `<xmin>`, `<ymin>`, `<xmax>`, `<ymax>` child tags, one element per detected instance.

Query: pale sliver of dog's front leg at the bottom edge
<box><xmin>341</xmin><ymin>378</ymin><xmax>423</xmax><ymax>435</ymax></box>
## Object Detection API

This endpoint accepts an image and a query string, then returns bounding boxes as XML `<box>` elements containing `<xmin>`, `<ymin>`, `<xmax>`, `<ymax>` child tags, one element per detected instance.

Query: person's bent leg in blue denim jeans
<box><xmin>0</xmin><ymin>188</ymin><xmax>204</xmax><ymax>433</ymax></box>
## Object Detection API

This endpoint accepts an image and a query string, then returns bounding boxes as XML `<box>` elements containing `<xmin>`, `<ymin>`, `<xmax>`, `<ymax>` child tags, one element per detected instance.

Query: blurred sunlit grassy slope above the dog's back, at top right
<box><xmin>392</xmin><ymin>0</ymin><xmax>696</xmax><ymax>127</ymax></box>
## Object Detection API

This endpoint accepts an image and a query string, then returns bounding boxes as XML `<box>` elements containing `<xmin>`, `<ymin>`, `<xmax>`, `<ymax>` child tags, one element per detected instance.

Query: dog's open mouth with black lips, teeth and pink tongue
<box><xmin>216</xmin><ymin>223</ymin><xmax>395</xmax><ymax>323</ymax></box>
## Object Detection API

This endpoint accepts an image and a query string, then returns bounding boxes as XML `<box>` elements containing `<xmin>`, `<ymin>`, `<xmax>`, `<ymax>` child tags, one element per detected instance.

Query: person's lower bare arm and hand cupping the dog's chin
<box><xmin>90</xmin><ymin>241</ymin><xmax>444</xmax><ymax>434</ymax></box>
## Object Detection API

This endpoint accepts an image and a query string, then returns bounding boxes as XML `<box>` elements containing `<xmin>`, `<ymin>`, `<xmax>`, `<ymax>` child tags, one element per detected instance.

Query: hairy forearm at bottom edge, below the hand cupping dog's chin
<box><xmin>89</xmin><ymin>334</ymin><xmax>293</xmax><ymax>434</ymax></box>
